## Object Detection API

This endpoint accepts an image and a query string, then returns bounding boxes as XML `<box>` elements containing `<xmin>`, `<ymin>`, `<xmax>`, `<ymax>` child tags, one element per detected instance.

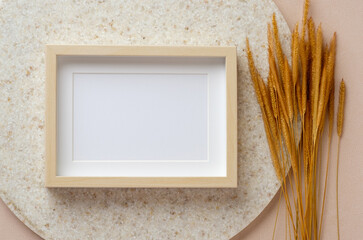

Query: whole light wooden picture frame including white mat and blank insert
<box><xmin>45</xmin><ymin>45</ymin><xmax>237</xmax><ymax>188</ymax></box>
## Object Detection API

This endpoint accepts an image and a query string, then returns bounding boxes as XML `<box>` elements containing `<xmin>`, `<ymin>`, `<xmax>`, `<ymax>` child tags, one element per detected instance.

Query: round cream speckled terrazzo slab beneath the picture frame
<box><xmin>0</xmin><ymin>0</ymin><xmax>289</xmax><ymax>240</ymax></box>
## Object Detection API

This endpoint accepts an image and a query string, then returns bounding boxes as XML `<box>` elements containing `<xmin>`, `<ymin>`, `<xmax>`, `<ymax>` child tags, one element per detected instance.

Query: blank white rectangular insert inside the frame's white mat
<box><xmin>73</xmin><ymin>73</ymin><xmax>209</xmax><ymax>162</ymax></box>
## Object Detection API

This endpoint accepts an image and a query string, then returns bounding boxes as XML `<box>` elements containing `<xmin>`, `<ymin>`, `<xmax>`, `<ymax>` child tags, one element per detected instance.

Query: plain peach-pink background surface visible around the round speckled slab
<box><xmin>0</xmin><ymin>0</ymin><xmax>363</xmax><ymax>240</ymax></box>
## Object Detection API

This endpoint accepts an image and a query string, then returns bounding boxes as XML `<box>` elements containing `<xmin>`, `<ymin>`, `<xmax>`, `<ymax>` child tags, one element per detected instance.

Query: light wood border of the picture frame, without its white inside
<box><xmin>45</xmin><ymin>45</ymin><xmax>237</xmax><ymax>188</ymax></box>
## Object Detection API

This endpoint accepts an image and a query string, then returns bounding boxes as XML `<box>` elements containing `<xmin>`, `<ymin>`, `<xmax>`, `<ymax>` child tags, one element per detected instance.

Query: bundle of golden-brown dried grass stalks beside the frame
<box><xmin>246</xmin><ymin>0</ymin><xmax>345</xmax><ymax>240</ymax></box>
